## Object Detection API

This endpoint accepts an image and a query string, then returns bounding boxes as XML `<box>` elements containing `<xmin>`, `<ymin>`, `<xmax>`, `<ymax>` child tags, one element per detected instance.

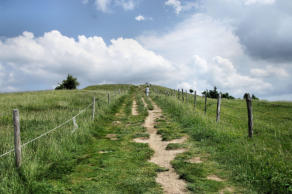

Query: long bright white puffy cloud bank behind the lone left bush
<box><xmin>0</xmin><ymin>31</ymin><xmax>174</xmax><ymax>91</ymax></box>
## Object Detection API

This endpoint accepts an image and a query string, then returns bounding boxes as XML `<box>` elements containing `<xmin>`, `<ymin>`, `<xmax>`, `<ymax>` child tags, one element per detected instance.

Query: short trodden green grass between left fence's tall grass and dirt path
<box><xmin>32</xmin><ymin>93</ymin><xmax>162</xmax><ymax>194</ymax></box>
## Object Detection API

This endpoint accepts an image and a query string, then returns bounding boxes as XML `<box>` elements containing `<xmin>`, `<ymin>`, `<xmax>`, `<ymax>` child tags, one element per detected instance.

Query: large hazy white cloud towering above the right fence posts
<box><xmin>138</xmin><ymin>14</ymin><xmax>290</xmax><ymax>97</ymax></box>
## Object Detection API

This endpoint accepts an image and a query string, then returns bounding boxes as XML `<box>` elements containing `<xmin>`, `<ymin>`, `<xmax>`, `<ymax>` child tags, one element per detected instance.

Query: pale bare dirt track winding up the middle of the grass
<box><xmin>135</xmin><ymin>102</ymin><xmax>187</xmax><ymax>194</ymax></box>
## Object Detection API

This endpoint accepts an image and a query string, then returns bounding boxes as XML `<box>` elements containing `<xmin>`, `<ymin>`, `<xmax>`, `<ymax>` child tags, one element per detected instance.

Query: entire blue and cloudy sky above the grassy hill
<box><xmin>0</xmin><ymin>0</ymin><xmax>292</xmax><ymax>100</ymax></box>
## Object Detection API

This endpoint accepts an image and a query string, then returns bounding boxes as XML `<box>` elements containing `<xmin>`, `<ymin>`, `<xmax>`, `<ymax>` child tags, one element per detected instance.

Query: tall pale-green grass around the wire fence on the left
<box><xmin>0</xmin><ymin>86</ymin><xmax>126</xmax><ymax>193</ymax></box>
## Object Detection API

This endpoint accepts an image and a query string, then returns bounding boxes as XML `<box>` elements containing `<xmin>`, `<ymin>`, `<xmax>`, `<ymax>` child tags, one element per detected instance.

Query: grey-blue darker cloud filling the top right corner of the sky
<box><xmin>202</xmin><ymin>0</ymin><xmax>292</xmax><ymax>63</ymax></box>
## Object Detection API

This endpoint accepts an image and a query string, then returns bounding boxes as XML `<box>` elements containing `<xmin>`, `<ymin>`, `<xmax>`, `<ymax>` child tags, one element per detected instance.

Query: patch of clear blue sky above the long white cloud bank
<box><xmin>0</xmin><ymin>0</ymin><xmax>184</xmax><ymax>42</ymax></box>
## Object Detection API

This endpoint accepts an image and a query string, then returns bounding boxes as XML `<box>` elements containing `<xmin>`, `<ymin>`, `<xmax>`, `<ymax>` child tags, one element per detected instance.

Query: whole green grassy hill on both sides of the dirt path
<box><xmin>0</xmin><ymin>84</ymin><xmax>292</xmax><ymax>193</ymax></box>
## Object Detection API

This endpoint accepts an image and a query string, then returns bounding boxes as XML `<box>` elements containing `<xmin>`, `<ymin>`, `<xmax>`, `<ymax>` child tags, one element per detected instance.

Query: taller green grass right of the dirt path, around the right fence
<box><xmin>152</xmin><ymin>87</ymin><xmax>292</xmax><ymax>193</ymax></box>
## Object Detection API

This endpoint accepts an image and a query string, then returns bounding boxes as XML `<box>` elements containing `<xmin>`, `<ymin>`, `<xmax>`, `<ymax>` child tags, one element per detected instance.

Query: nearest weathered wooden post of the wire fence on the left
<box><xmin>13</xmin><ymin>109</ymin><xmax>21</xmax><ymax>168</ymax></box>
